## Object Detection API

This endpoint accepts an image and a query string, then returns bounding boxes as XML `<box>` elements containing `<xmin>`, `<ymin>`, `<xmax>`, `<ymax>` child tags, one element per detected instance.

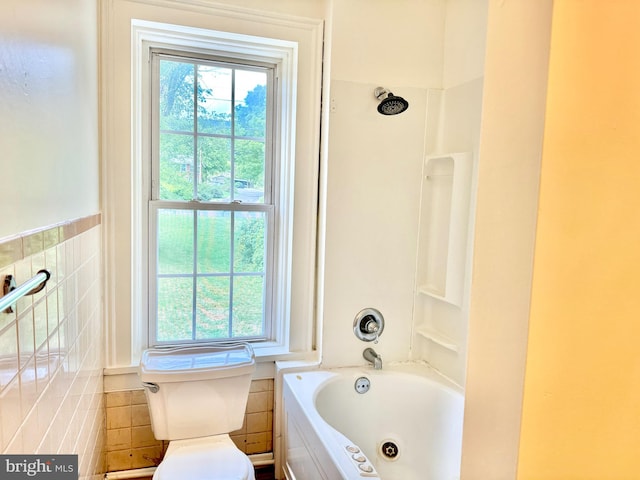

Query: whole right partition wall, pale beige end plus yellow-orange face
<box><xmin>462</xmin><ymin>0</ymin><xmax>640</xmax><ymax>480</ymax></box>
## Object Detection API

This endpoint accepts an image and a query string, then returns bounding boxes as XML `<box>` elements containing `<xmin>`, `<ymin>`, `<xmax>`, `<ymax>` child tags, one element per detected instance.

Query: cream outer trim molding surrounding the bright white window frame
<box><xmin>99</xmin><ymin>0</ymin><xmax>322</xmax><ymax>372</ymax></box>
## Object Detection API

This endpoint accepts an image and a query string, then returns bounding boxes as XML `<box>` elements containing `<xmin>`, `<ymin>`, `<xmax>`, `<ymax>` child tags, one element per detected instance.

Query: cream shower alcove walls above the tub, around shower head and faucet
<box><xmin>320</xmin><ymin>0</ymin><xmax>488</xmax><ymax>385</ymax></box>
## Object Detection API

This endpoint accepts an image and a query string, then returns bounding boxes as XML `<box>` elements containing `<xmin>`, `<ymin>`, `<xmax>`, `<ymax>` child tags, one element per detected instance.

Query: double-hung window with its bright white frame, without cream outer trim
<box><xmin>132</xmin><ymin>18</ymin><xmax>306</xmax><ymax>355</ymax></box>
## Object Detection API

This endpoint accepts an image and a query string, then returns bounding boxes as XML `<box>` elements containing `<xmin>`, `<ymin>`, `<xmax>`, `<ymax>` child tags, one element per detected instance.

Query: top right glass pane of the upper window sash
<box><xmin>235</xmin><ymin>70</ymin><xmax>267</xmax><ymax>139</ymax></box>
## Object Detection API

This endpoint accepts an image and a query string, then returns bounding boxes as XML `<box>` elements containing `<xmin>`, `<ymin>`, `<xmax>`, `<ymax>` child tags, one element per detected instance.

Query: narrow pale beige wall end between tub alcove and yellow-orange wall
<box><xmin>462</xmin><ymin>0</ymin><xmax>552</xmax><ymax>480</ymax></box>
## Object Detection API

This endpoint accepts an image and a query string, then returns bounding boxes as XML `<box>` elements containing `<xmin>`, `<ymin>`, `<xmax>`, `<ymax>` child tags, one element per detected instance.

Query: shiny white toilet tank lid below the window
<box><xmin>140</xmin><ymin>343</ymin><xmax>255</xmax><ymax>382</ymax></box>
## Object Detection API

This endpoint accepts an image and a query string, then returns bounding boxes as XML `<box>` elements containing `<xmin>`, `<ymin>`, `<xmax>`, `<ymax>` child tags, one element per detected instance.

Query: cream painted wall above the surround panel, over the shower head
<box><xmin>329</xmin><ymin>0</ymin><xmax>445</xmax><ymax>86</ymax></box>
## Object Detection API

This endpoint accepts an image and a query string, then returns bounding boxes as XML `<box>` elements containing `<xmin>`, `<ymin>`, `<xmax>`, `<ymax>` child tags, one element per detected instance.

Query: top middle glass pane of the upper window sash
<box><xmin>198</xmin><ymin>65</ymin><xmax>232</xmax><ymax>135</ymax></box>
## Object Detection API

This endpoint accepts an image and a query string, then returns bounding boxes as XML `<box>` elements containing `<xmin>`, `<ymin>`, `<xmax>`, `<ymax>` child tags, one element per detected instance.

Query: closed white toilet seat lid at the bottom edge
<box><xmin>153</xmin><ymin>435</ymin><xmax>255</xmax><ymax>480</ymax></box>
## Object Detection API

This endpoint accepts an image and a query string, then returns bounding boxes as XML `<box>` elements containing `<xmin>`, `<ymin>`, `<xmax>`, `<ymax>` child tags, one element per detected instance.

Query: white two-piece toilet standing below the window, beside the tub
<box><xmin>139</xmin><ymin>343</ymin><xmax>255</xmax><ymax>480</ymax></box>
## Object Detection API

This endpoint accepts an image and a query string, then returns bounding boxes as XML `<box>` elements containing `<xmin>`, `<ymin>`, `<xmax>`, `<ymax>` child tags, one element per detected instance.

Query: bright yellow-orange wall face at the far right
<box><xmin>518</xmin><ymin>0</ymin><xmax>640</xmax><ymax>480</ymax></box>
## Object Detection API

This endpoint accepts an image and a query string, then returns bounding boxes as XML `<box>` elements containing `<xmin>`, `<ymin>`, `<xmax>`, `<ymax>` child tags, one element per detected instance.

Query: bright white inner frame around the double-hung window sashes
<box><xmin>131</xmin><ymin>20</ymin><xmax>298</xmax><ymax>354</ymax></box>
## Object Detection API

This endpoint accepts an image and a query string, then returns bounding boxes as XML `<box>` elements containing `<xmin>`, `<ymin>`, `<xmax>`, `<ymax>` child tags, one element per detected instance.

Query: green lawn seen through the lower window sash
<box><xmin>157</xmin><ymin>210</ymin><xmax>264</xmax><ymax>342</ymax></box>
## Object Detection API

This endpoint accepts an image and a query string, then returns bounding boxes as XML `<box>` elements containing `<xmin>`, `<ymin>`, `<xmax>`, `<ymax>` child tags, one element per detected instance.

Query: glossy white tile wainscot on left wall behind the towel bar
<box><xmin>0</xmin><ymin>225</ymin><xmax>104</xmax><ymax>479</ymax></box>
